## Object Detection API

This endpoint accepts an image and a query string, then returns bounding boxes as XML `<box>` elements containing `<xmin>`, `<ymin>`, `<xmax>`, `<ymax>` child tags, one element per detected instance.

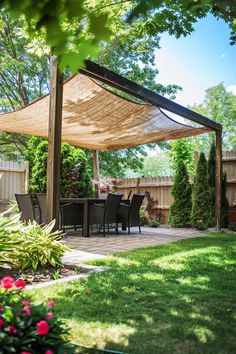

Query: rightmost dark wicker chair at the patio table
<box><xmin>118</xmin><ymin>194</ymin><xmax>145</xmax><ymax>234</ymax></box>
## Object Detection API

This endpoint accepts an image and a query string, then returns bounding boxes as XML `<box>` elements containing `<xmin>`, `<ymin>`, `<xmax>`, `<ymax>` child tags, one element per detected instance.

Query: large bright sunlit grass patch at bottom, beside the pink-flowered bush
<box><xmin>67</xmin><ymin>320</ymin><xmax>135</xmax><ymax>349</ymax></box>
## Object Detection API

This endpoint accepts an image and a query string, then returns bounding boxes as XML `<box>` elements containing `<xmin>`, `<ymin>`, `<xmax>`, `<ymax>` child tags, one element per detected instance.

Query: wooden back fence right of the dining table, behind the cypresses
<box><xmin>118</xmin><ymin>151</ymin><xmax>236</xmax><ymax>224</ymax></box>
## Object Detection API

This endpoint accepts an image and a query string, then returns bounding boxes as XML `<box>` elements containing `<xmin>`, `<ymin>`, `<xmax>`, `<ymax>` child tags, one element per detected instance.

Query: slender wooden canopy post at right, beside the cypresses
<box><xmin>215</xmin><ymin>130</ymin><xmax>222</xmax><ymax>231</ymax></box>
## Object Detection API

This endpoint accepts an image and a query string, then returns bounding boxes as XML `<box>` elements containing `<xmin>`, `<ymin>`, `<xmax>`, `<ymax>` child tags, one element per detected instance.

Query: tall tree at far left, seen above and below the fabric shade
<box><xmin>0</xmin><ymin>9</ymin><xmax>49</xmax><ymax>159</ymax></box>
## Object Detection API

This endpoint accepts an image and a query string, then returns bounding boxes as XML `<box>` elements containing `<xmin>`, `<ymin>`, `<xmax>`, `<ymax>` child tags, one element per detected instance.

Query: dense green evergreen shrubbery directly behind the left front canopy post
<box><xmin>30</xmin><ymin>140</ymin><xmax>93</xmax><ymax>197</ymax></box>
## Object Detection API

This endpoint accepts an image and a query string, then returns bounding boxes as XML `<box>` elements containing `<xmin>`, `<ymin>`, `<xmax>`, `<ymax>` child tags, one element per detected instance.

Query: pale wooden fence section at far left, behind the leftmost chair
<box><xmin>0</xmin><ymin>160</ymin><xmax>29</xmax><ymax>211</ymax></box>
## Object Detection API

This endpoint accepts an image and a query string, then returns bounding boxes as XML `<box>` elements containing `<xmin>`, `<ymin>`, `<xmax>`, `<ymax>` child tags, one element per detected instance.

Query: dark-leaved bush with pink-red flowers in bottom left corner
<box><xmin>0</xmin><ymin>276</ymin><xmax>74</xmax><ymax>354</ymax></box>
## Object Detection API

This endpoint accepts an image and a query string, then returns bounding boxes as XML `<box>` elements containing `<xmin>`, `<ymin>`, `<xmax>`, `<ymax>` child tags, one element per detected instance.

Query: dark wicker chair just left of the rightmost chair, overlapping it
<box><xmin>89</xmin><ymin>193</ymin><xmax>123</xmax><ymax>237</ymax></box>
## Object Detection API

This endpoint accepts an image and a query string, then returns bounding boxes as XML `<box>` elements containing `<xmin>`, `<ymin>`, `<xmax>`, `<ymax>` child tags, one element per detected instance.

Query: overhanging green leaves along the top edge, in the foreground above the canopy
<box><xmin>0</xmin><ymin>0</ymin><xmax>236</xmax><ymax>71</ymax></box>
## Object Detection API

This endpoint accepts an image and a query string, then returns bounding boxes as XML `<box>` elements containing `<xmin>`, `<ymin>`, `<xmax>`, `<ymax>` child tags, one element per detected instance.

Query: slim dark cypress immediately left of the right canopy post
<box><xmin>207</xmin><ymin>142</ymin><xmax>216</xmax><ymax>226</ymax></box>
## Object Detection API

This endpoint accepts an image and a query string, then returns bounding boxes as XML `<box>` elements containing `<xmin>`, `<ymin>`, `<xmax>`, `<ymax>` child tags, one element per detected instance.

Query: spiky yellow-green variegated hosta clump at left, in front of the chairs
<box><xmin>0</xmin><ymin>214</ymin><xmax>69</xmax><ymax>269</ymax></box>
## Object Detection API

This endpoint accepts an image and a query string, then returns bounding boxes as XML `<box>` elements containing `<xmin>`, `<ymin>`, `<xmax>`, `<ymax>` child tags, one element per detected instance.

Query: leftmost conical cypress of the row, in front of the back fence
<box><xmin>168</xmin><ymin>160</ymin><xmax>192</xmax><ymax>227</ymax></box>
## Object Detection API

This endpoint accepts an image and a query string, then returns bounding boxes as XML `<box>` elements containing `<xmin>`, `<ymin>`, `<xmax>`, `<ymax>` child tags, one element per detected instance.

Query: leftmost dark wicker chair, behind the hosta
<box><xmin>15</xmin><ymin>193</ymin><xmax>40</xmax><ymax>224</ymax></box>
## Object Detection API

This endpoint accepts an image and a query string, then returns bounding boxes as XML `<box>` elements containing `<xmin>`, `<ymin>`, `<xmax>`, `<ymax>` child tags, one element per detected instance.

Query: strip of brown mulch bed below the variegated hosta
<box><xmin>0</xmin><ymin>266</ymin><xmax>89</xmax><ymax>285</ymax></box>
